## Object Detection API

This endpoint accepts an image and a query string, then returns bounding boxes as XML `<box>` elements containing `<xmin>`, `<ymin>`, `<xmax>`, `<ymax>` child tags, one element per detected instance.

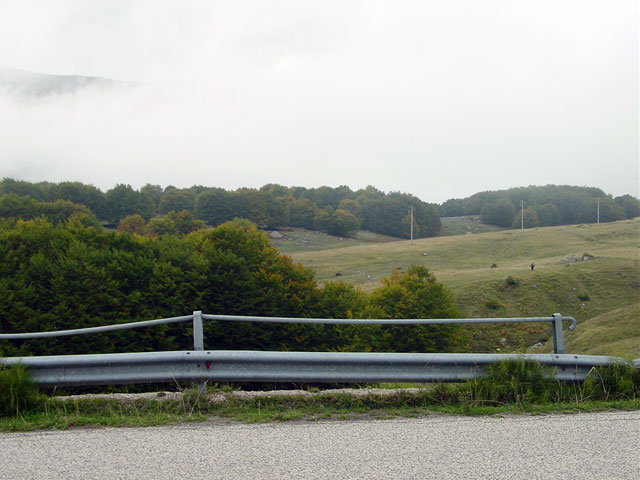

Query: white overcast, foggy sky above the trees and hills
<box><xmin>0</xmin><ymin>0</ymin><xmax>640</xmax><ymax>203</ymax></box>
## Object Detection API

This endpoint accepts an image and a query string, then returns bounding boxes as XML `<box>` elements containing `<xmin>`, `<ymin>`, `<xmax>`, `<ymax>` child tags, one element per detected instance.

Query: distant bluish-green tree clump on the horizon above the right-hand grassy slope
<box><xmin>439</xmin><ymin>185</ymin><xmax>640</xmax><ymax>228</ymax></box>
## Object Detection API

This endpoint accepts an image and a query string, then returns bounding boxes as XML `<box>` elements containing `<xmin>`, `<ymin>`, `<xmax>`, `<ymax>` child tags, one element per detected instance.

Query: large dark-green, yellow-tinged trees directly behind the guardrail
<box><xmin>0</xmin><ymin>215</ymin><xmax>461</xmax><ymax>356</ymax></box>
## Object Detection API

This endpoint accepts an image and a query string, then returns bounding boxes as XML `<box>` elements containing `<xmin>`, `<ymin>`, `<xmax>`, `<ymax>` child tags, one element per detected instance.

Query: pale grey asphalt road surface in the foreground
<box><xmin>0</xmin><ymin>411</ymin><xmax>640</xmax><ymax>480</ymax></box>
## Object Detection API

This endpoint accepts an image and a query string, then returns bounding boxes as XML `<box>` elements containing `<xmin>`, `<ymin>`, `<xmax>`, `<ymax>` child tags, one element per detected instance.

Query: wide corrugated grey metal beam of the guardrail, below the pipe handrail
<box><xmin>0</xmin><ymin>351</ymin><xmax>624</xmax><ymax>386</ymax></box>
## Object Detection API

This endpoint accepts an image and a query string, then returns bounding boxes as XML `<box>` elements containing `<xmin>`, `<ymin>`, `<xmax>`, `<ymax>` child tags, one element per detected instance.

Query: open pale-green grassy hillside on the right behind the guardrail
<box><xmin>292</xmin><ymin>219</ymin><xmax>640</xmax><ymax>358</ymax></box>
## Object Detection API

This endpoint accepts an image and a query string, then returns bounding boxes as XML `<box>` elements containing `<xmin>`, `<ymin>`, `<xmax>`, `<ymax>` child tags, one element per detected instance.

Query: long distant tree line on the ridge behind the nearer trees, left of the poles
<box><xmin>0</xmin><ymin>178</ymin><xmax>441</xmax><ymax>238</ymax></box>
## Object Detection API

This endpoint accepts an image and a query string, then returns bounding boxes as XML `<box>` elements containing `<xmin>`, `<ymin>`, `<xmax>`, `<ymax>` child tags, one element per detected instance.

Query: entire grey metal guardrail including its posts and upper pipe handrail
<box><xmin>0</xmin><ymin>311</ymin><xmax>636</xmax><ymax>387</ymax></box>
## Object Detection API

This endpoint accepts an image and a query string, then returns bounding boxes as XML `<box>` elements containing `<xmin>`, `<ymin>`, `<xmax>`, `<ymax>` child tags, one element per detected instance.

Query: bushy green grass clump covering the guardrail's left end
<box><xmin>0</xmin><ymin>365</ymin><xmax>41</xmax><ymax>417</ymax></box>
